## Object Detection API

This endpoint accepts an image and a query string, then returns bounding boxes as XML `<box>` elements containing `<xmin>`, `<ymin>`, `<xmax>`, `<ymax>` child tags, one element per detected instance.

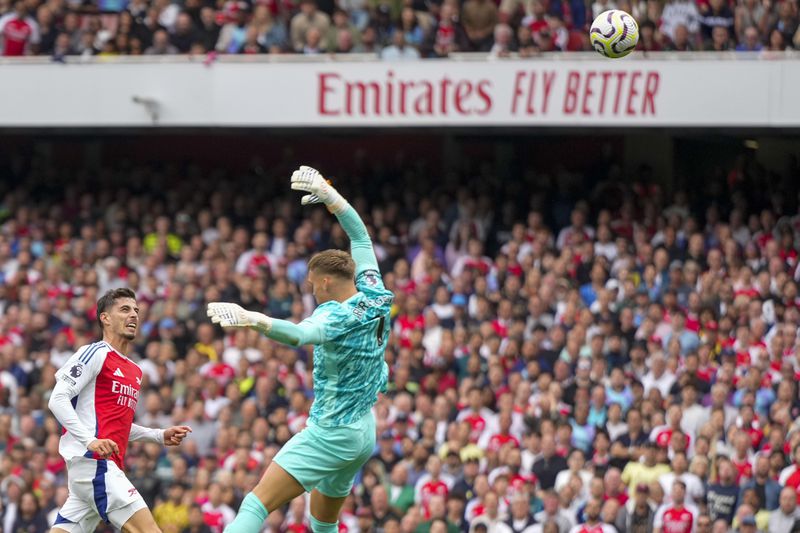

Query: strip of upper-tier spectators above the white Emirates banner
<box><xmin>0</xmin><ymin>0</ymin><xmax>800</xmax><ymax>59</ymax></box>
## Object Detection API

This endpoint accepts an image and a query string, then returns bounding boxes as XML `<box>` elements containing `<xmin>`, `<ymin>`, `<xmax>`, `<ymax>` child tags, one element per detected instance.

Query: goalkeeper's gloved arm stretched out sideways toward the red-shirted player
<box><xmin>206</xmin><ymin>302</ymin><xmax>326</xmax><ymax>346</ymax></box>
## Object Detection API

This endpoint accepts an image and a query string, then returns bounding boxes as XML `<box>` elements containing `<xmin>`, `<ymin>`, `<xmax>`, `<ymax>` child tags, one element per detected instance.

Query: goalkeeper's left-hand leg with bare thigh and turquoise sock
<box><xmin>225</xmin><ymin>461</ymin><xmax>305</xmax><ymax>533</ymax></box>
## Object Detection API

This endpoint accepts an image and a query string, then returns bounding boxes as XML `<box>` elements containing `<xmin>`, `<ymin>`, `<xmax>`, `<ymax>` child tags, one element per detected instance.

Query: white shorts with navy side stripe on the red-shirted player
<box><xmin>53</xmin><ymin>457</ymin><xmax>147</xmax><ymax>533</ymax></box>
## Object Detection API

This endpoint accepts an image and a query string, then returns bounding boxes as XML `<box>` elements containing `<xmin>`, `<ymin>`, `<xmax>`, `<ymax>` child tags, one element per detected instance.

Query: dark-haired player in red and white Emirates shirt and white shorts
<box><xmin>48</xmin><ymin>288</ymin><xmax>191</xmax><ymax>533</ymax></box>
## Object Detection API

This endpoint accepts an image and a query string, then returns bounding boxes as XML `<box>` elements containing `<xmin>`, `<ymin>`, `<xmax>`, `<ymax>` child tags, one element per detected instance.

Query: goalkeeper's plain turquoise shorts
<box><xmin>273</xmin><ymin>411</ymin><xmax>376</xmax><ymax>498</ymax></box>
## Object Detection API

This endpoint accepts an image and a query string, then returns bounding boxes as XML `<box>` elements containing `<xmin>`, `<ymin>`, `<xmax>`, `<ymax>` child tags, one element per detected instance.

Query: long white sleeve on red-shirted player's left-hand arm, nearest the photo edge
<box><xmin>47</xmin><ymin>344</ymin><xmax>107</xmax><ymax>446</ymax></box>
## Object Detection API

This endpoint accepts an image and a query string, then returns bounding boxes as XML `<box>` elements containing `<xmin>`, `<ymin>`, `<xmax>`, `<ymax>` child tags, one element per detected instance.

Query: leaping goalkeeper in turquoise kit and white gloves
<box><xmin>208</xmin><ymin>166</ymin><xmax>394</xmax><ymax>533</ymax></box>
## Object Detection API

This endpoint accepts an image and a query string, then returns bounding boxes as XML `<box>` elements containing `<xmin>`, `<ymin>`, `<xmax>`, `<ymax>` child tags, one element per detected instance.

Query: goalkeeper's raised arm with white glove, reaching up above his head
<box><xmin>292</xmin><ymin>166</ymin><xmax>378</xmax><ymax>278</ymax></box>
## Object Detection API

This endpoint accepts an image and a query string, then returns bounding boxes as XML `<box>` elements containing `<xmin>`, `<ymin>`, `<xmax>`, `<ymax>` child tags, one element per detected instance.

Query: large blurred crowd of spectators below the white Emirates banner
<box><xmin>0</xmin><ymin>142</ymin><xmax>800</xmax><ymax>533</ymax></box>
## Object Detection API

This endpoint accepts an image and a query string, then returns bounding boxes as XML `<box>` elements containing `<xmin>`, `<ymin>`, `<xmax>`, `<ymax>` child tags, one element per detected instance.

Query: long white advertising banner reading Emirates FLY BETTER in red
<box><xmin>0</xmin><ymin>57</ymin><xmax>800</xmax><ymax>127</ymax></box>
